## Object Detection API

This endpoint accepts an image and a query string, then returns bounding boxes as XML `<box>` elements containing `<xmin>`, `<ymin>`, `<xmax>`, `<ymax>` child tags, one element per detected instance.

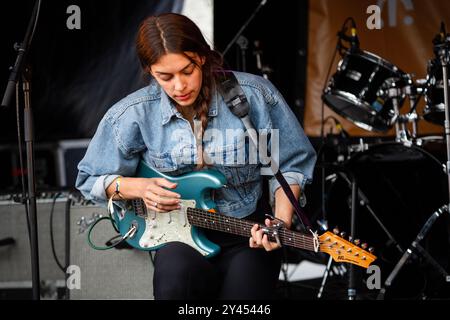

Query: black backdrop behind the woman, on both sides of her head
<box><xmin>0</xmin><ymin>0</ymin><xmax>307</xmax><ymax>143</ymax></box>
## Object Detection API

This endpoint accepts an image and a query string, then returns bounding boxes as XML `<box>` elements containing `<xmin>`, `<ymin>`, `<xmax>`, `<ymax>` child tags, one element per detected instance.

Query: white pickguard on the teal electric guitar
<box><xmin>139</xmin><ymin>200</ymin><xmax>208</xmax><ymax>255</ymax></box>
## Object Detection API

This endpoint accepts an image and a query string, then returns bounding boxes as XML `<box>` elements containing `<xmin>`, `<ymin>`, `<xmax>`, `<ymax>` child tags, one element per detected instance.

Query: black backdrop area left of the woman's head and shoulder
<box><xmin>0</xmin><ymin>0</ymin><xmax>183</xmax><ymax>142</ymax></box>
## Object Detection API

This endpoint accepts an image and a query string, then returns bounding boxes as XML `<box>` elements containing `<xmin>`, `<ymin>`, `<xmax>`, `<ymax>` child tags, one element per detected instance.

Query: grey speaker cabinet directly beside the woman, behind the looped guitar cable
<box><xmin>70</xmin><ymin>205</ymin><xmax>153</xmax><ymax>299</ymax></box>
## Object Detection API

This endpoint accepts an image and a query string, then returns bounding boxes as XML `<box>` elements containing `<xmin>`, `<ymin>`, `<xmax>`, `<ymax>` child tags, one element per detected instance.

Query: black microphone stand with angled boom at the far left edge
<box><xmin>1</xmin><ymin>0</ymin><xmax>41</xmax><ymax>300</ymax></box>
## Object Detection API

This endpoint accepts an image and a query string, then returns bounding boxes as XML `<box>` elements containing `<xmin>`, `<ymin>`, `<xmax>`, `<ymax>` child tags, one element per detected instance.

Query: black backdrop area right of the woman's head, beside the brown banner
<box><xmin>214</xmin><ymin>0</ymin><xmax>308</xmax><ymax>122</ymax></box>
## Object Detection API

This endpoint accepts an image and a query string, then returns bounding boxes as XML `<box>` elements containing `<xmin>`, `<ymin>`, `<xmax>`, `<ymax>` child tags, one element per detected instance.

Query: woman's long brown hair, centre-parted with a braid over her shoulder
<box><xmin>136</xmin><ymin>13</ymin><xmax>223</xmax><ymax>168</ymax></box>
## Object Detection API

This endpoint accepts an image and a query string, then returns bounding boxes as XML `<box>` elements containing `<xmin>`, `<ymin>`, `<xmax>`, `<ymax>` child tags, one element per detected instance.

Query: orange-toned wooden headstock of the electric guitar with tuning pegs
<box><xmin>319</xmin><ymin>231</ymin><xmax>377</xmax><ymax>268</ymax></box>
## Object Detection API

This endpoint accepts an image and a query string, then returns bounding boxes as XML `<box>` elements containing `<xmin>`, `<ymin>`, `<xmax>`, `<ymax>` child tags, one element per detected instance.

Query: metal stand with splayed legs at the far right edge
<box><xmin>377</xmin><ymin>39</ymin><xmax>450</xmax><ymax>300</ymax></box>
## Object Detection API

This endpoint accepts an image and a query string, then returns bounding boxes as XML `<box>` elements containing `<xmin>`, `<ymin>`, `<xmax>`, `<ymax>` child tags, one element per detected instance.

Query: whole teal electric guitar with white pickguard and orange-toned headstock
<box><xmin>110</xmin><ymin>161</ymin><xmax>376</xmax><ymax>268</ymax></box>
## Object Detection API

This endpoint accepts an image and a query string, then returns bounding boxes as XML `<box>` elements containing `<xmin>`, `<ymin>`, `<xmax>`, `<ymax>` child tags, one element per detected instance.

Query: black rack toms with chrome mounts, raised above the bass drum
<box><xmin>322</xmin><ymin>27</ymin><xmax>445</xmax><ymax>143</ymax></box>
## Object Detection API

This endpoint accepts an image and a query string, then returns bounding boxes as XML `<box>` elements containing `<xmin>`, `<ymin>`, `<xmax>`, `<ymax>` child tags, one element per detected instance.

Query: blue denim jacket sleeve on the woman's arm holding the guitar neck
<box><xmin>241</xmin><ymin>77</ymin><xmax>316</xmax><ymax>203</ymax></box>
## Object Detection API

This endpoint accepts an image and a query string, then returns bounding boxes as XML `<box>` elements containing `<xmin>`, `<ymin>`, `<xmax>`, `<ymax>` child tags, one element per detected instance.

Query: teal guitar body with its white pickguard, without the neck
<box><xmin>113</xmin><ymin>161</ymin><xmax>226</xmax><ymax>257</ymax></box>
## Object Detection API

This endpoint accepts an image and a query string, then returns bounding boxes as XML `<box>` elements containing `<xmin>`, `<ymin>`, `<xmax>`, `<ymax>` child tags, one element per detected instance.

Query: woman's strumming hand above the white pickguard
<box><xmin>140</xmin><ymin>178</ymin><xmax>181</xmax><ymax>212</ymax></box>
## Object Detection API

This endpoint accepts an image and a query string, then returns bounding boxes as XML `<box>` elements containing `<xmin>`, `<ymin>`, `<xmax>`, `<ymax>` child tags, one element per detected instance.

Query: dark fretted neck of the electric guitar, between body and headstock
<box><xmin>187</xmin><ymin>208</ymin><xmax>315</xmax><ymax>251</ymax></box>
